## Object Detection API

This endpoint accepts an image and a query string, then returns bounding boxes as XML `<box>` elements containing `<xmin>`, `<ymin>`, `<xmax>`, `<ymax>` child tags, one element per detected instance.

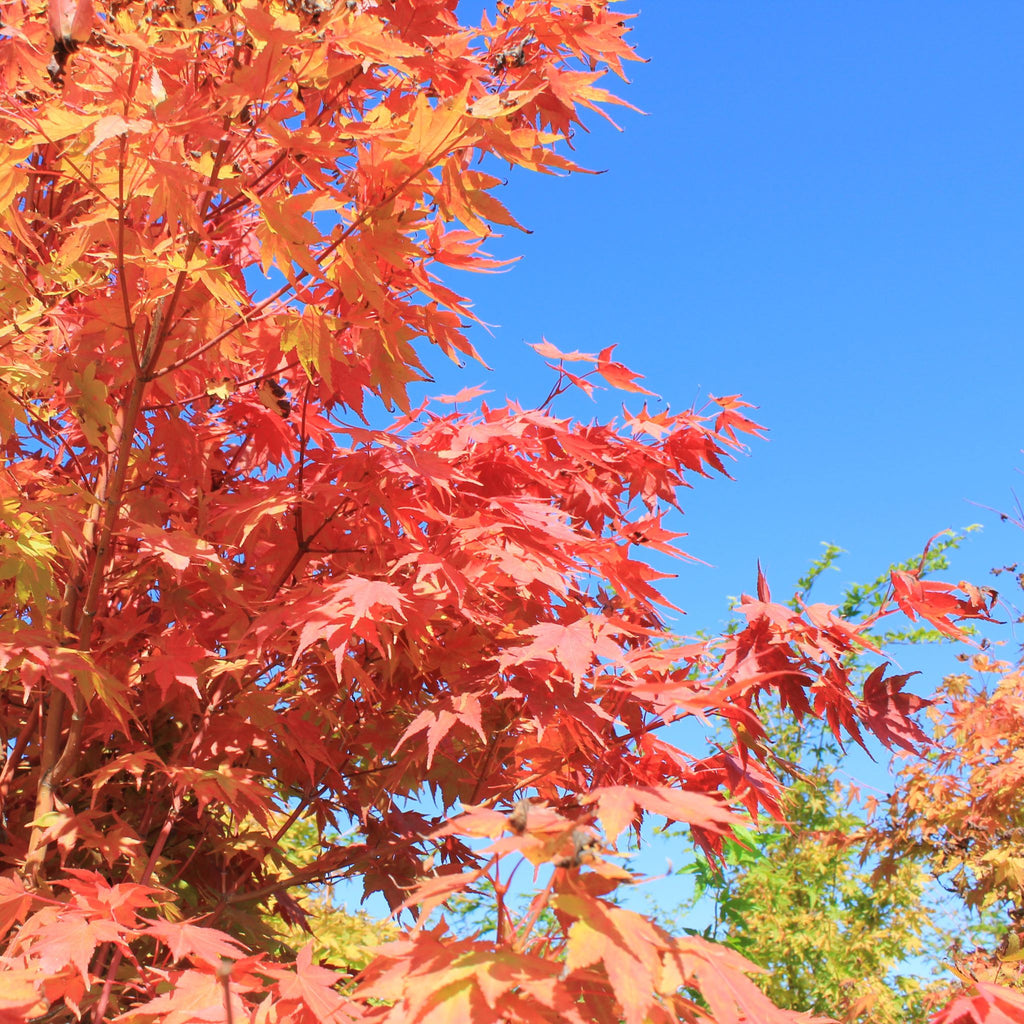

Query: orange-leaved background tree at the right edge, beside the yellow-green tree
<box><xmin>872</xmin><ymin>552</ymin><xmax>1024</xmax><ymax>1007</ymax></box>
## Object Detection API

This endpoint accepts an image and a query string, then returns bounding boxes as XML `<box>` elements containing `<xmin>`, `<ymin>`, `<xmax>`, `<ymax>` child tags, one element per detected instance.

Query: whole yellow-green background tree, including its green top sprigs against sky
<box><xmin>658</xmin><ymin>540</ymin><xmax>984</xmax><ymax>1024</ymax></box>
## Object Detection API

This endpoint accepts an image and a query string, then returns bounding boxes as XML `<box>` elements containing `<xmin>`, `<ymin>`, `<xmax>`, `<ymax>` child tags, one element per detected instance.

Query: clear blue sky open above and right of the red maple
<box><xmin>419</xmin><ymin>0</ymin><xmax>1024</xmax><ymax>668</ymax></box>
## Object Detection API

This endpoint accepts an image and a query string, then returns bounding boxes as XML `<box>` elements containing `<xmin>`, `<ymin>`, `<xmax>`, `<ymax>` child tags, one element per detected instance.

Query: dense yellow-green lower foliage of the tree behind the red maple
<box><xmin>659</xmin><ymin>713</ymin><xmax>950</xmax><ymax>1024</ymax></box>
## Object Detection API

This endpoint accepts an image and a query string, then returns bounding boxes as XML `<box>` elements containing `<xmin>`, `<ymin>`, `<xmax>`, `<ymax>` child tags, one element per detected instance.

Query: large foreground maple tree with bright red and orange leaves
<box><xmin>0</xmin><ymin>0</ymin><xmax>988</xmax><ymax>1024</ymax></box>
